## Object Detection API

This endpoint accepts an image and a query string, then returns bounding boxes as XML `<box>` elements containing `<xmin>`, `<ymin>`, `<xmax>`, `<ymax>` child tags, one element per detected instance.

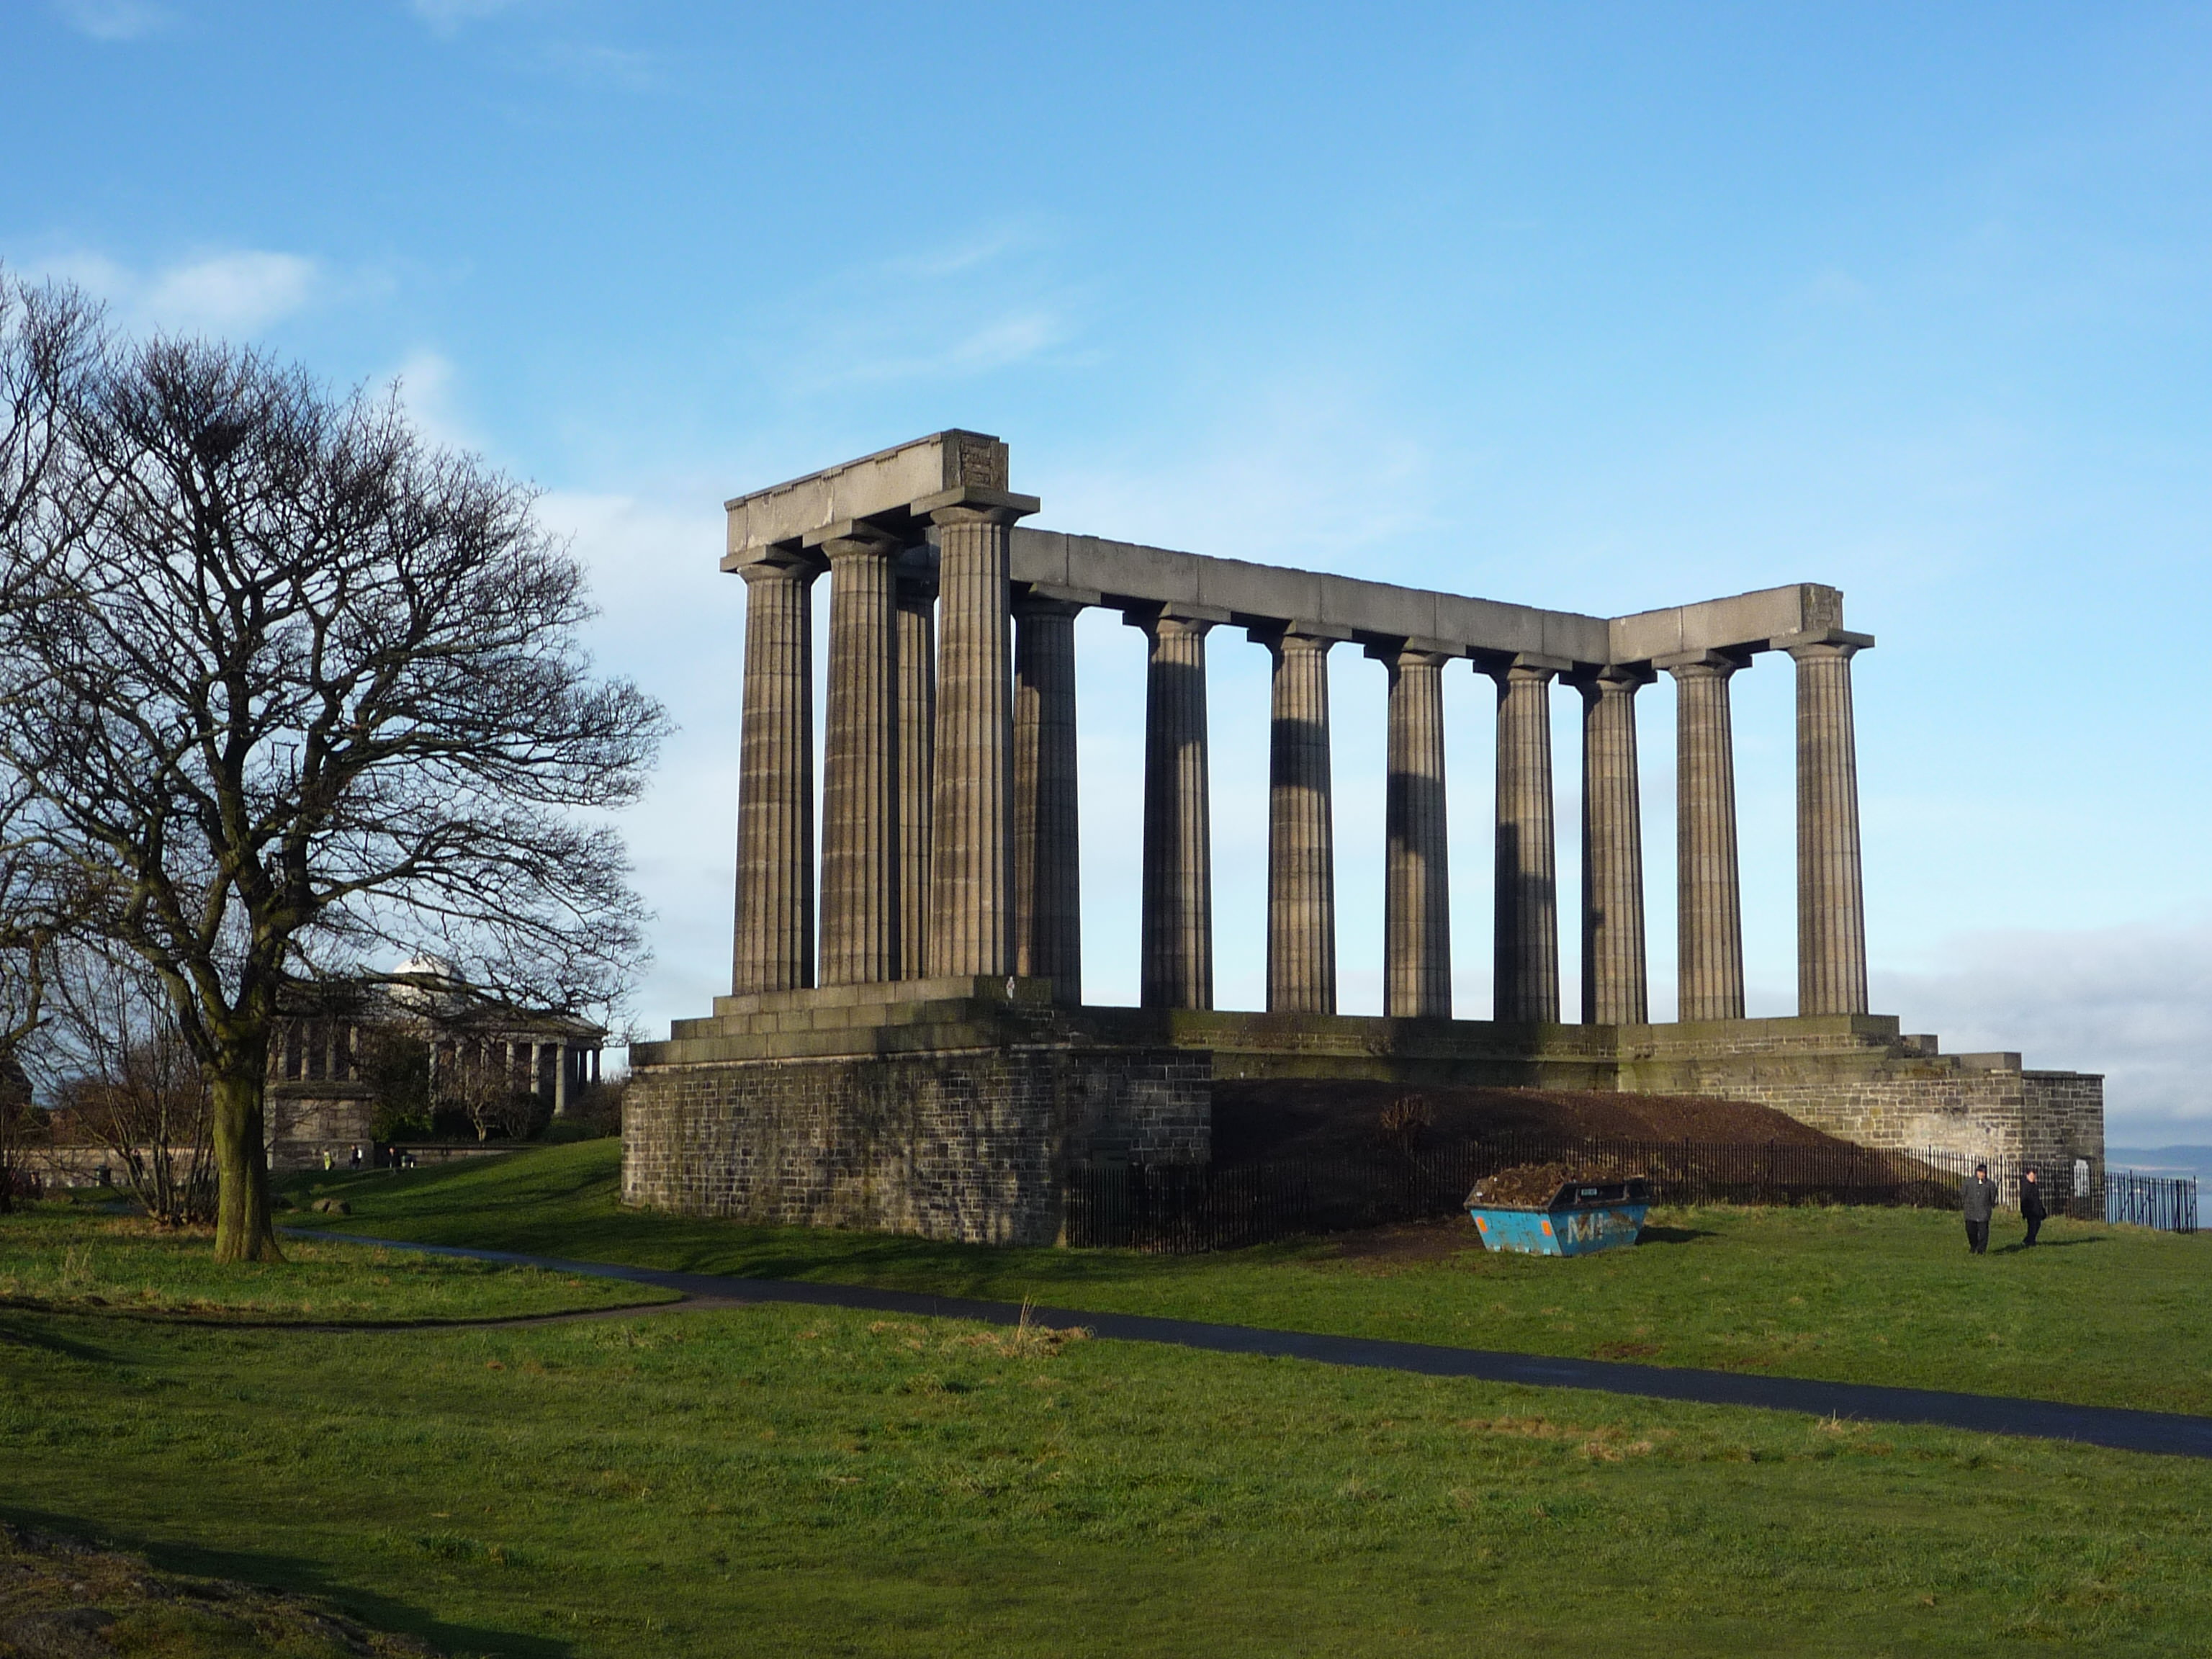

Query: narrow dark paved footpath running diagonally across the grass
<box><xmin>301</xmin><ymin>1228</ymin><xmax>2212</xmax><ymax>1457</ymax></box>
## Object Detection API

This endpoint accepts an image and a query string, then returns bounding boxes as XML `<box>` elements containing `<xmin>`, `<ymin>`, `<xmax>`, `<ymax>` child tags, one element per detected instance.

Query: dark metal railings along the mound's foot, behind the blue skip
<box><xmin>1062</xmin><ymin>1135</ymin><xmax>2149</xmax><ymax>1254</ymax></box>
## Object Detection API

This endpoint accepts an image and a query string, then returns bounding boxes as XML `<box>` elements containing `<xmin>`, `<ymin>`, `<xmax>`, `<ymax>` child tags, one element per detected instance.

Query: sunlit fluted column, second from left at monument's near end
<box><xmin>819</xmin><ymin>524</ymin><xmax>900</xmax><ymax>984</ymax></box>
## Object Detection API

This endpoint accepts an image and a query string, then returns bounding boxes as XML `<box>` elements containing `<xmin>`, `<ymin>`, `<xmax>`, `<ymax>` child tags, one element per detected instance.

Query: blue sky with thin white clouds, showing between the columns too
<box><xmin>0</xmin><ymin>0</ymin><xmax>2212</xmax><ymax>1141</ymax></box>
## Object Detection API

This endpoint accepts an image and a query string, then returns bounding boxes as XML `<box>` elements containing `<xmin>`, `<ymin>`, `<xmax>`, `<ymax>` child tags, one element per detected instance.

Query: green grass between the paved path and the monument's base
<box><xmin>305</xmin><ymin>1141</ymin><xmax>2212</xmax><ymax>1413</ymax></box>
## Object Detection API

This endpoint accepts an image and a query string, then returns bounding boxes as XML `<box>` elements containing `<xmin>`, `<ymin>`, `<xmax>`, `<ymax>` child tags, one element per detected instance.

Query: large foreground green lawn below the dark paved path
<box><xmin>13</xmin><ymin>1305</ymin><xmax>2212</xmax><ymax>1659</ymax></box>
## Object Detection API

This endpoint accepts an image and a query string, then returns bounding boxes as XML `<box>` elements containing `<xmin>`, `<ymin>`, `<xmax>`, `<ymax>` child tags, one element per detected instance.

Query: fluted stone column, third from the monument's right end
<box><xmin>1575</xmin><ymin>666</ymin><xmax>1653</xmax><ymax>1026</ymax></box>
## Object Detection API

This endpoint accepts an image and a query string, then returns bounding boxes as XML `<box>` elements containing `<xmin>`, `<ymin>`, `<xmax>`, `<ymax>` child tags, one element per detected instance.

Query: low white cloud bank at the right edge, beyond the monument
<box><xmin>1874</xmin><ymin>920</ymin><xmax>2212</xmax><ymax>1143</ymax></box>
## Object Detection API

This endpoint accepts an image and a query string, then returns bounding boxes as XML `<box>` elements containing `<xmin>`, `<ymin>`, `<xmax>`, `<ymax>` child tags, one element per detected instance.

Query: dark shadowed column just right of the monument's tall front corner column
<box><xmin>1013</xmin><ymin>588</ymin><xmax>1084</xmax><ymax>1002</ymax></box>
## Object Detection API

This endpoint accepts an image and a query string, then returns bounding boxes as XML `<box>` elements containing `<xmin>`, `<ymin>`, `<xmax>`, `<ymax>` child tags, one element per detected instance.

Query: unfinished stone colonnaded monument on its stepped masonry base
<box><xmin>624</xmin><ymin>431</ymin><xmax>2103</xmax><ymax>1241</ymax></box>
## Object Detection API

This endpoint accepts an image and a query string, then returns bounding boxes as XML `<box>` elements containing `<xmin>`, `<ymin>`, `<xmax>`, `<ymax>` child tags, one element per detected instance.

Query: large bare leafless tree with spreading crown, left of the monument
<box><xmin>0</xmin><ymin>276</ymin><xmax>666</xmax><ymax>1261</ymax></box>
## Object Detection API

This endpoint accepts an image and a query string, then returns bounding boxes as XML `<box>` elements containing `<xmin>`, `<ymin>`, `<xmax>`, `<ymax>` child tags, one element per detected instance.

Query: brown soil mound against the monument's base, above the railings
<box><xmin>1215</xmin><ymin>1079</ymin><xmax>1838</xmax><ymax>1179</ymax></box>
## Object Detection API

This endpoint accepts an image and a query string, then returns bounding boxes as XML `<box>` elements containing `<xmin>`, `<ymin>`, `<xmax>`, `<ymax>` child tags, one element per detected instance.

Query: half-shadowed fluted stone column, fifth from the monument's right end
<box><xmin>1374</xmin><ymin>644</ymin><xmax>1451</xmax><ymax>1020</ymax></box>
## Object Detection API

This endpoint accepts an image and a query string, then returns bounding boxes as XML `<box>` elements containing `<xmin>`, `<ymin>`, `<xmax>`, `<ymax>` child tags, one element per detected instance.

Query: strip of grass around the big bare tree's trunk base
<box><xmin>0</xmin><ymin>1201</ymin><xmax>673</xmax><ymax>1323</ymax></box>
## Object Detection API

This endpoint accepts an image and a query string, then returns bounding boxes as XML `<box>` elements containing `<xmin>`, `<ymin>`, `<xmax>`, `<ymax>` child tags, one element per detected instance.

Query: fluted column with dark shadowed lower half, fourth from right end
<box><xmin>1486</xmin><ymin>657</ymin><xmax>1568</xmax><ymax>1022</ymax></box>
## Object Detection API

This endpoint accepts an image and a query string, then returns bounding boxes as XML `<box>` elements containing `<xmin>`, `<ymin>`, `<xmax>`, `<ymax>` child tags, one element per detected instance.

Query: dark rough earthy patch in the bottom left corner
<box><xmin>0</xmin><ymin>1522</ymin><xmax>438</xmax><ymax>1659</ymax></box>
